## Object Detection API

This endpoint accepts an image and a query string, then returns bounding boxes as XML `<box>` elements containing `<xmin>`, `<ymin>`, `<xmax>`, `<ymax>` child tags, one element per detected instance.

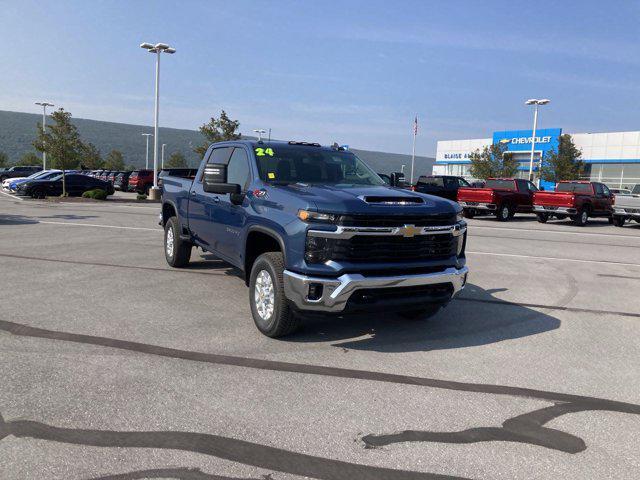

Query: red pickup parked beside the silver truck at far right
<box><xmin>533</xmin><ymin>181</ymin><xmax>613</xmax><ymax>226</ymax></box>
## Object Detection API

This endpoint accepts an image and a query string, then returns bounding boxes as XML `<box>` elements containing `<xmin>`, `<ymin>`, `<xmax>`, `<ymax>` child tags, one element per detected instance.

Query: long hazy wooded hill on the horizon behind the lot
<box><xmin>0</xmin><ymin>110</ymin><xmax>435</xmax><ymax>176</ymax></box>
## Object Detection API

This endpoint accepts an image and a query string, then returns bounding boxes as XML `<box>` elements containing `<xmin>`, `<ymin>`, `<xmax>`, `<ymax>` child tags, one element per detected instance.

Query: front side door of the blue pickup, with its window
<box><xmin>218</xmin><ymin>147</ymin><xmax>252</xmax><ymax>265</ymax></box>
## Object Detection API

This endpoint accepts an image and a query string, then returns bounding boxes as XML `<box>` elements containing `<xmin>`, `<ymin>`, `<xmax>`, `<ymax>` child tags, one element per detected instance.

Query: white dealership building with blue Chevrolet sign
<box><xmin>433</xmin><ymin>128</ymin><xmax>640</xmax><ymax>188</ymax></box>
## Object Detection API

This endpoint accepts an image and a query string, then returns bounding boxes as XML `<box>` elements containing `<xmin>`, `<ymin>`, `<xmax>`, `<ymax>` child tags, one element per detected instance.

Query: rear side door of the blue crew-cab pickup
<box><xmin>189</xmin><ymin>147</ymin><xmax>233</xmax><ymax>252</ymax></box>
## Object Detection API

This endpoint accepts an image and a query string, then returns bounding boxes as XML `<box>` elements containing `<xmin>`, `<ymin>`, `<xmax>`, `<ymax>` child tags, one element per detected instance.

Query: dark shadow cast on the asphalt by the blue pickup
<box><xmin>286</xmin><ymin>284</ymin><xmax>560</xmax><ymax>353</ymax></box>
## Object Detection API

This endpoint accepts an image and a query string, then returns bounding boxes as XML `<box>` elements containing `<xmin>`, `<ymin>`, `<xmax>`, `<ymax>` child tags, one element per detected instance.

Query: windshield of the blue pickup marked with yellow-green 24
<box><xmin>254</xmin><ymin>144</ymin><xmax>385</xmax><ymax>185</ymax></box>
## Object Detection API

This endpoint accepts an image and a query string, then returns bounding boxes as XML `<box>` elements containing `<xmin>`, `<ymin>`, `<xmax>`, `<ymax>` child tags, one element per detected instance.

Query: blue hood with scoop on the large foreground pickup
<box><xmin>278</xmin><ymin>184</ymin><xmax>460</xmax><ymax>215</ymax></box>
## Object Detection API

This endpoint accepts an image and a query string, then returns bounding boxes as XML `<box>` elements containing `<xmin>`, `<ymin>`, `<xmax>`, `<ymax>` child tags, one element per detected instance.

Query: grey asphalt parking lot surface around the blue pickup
<box><xmin>0</xmin><ymin>195</ymin><xmax>640</xmax><ymax>480</ymax></box>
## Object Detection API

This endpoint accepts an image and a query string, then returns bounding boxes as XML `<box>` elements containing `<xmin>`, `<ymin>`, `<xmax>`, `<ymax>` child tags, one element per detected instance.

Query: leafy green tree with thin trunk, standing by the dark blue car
<box><xmin>33</xmin><ymin>108</ymin><xmax>84</xmax><ymax>196</ymax></box>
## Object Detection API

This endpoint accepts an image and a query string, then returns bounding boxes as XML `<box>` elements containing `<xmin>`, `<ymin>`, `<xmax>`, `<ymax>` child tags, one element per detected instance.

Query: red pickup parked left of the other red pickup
<box><xmin>458</xmin><ymin>178</ymin><xmax>538</xmax><ymax>222</ymax></box>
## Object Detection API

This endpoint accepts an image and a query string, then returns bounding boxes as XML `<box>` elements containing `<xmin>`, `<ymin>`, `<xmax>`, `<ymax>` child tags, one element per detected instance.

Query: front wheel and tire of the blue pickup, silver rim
<box><xmin>249</xmin><ymin>252</ymin><xmax>299</xmax><ymax>338</ymax></box>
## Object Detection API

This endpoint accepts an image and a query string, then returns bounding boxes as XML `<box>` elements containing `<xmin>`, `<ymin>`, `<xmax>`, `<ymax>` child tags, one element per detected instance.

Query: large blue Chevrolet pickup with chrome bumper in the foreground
<box><xmin>160</xmin><ymin>140</ymin><xmax>468</xmax><ymax>337</ymax></box>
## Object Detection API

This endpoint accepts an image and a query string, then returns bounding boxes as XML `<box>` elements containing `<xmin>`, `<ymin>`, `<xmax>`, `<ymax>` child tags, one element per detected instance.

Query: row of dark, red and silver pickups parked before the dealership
<box><xmin>412</xmin><ymin>175</ymin><xmax>640</xmax><ymax>226</ymax></box>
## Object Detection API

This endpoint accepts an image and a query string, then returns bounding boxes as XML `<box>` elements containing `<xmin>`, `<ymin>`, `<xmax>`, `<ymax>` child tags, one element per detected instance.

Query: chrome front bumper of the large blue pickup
<box><xmin>283</xmin><ymin>267</ymin><xmax>469</xmax><ymax>312</ymax></box>
